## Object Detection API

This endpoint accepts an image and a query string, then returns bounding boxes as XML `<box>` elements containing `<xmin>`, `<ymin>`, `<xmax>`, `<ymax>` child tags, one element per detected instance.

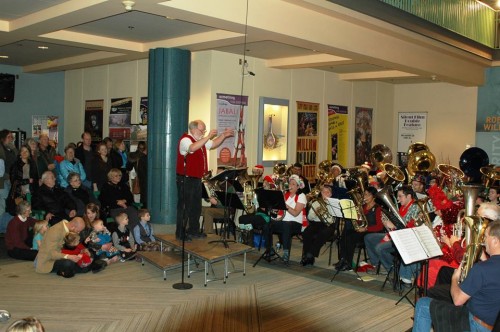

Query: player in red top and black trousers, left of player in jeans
<box><xmin>335</xmin><ymin>187</ymin><xmax>384</xmax><ymax>271</ymax></box>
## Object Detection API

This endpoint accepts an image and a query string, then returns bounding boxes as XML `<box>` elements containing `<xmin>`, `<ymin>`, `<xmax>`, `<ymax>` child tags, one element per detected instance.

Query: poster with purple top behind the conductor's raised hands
<box><xmin>216</xmin><ymin>93</ymin><xmax>248</xmax><ymax>166</ymax></box>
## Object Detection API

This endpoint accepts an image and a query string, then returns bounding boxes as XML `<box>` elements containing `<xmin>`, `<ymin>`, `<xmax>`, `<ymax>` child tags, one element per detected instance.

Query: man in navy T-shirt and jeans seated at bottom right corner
<box><xmin>413</xmin><ymin>221</ymin><xmax>500</xmax><ymax>331</ymax></box>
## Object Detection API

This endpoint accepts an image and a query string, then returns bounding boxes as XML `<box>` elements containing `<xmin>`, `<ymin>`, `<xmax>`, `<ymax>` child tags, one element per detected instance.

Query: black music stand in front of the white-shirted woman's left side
<box><xmin>253</xmin><ymin>188</ymin><xmax>286</xmax><ymax>267</ymax></box>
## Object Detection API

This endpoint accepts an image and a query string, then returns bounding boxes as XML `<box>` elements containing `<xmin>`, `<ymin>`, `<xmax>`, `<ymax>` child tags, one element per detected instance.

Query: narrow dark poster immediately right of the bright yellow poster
<box><xmin>354</xmin><ymin>107</ymin><xmax>373</xmax><ymax>165</ymax></box>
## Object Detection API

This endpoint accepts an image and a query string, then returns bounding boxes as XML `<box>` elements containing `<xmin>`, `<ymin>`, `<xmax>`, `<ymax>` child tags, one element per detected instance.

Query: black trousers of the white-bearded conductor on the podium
<box><xmin>175</xmin><ymin>175</ymin><xmax>202</xmax><ymax>237</ymax></box>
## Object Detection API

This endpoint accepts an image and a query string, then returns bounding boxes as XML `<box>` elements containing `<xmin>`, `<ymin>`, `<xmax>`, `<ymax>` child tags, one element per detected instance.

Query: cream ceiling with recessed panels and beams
<box><xmin>0</xmin><ymin>0</ymin><xmax>492</xmax><ymax>86</ymax></box>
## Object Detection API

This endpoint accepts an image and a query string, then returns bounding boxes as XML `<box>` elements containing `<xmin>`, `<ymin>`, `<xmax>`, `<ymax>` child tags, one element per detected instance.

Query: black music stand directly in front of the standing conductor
<box><xmin>209</xmin><ymin>169</ymin><xmax>246</xmax><ymax>248</ymax></box>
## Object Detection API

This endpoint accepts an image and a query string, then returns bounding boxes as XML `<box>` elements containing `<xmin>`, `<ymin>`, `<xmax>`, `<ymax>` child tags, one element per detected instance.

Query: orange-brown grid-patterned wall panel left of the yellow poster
<box><xmin>295</xmin><ymin>101</ymin><xmax>319</xmax><ymax>181</ymax></box>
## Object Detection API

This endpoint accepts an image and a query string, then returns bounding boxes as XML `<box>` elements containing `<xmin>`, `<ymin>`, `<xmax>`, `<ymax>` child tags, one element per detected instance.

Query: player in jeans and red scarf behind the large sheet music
<box><xmin>365</xmin><ymin>186</ymin><xmax>420</xmax><ymax>283</ymax></box>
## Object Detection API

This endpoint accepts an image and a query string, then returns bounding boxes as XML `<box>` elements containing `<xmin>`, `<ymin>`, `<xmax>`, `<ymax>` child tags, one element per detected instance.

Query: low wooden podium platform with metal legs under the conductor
<box><xmin>155</xmin><ymin>234</ymin><xmax>253</xmax><ymax>286</ymax></box>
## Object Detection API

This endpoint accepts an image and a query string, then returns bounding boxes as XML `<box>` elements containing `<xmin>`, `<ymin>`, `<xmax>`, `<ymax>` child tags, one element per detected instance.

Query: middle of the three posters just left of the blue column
<box><xmin>109</xmin><ymin>97</ymin><xmax>132</xmax><ymax>140</ymax></box>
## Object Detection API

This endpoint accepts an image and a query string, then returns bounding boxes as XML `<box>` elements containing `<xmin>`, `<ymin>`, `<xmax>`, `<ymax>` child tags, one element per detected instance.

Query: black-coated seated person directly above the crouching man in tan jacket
<box><xmin>32</xmin><ymin>171</ymin><xmax>76</xmax><ymax>225</ymax></box>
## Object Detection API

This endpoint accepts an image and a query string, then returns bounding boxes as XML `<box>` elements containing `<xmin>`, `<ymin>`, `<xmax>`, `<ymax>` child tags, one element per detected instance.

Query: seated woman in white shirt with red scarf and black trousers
<box><xmin>270</xmin><ymin>174</ymin><xmax>307</xmax><ymax>263</ymax></box>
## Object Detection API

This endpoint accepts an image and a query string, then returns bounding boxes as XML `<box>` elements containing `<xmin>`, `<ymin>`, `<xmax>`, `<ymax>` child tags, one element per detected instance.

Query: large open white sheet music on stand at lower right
<box><xmin>389</xmin><ymin>225</ymin><xmax>443</xmax><ymax>264</ymax></box>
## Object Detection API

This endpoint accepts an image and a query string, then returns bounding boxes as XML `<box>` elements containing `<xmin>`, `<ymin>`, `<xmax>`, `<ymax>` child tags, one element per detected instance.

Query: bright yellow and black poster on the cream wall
<box><xmin>328</xmin><ymin>105</ymin><xmax>349</xmax><ymax>165</ymax></box>
